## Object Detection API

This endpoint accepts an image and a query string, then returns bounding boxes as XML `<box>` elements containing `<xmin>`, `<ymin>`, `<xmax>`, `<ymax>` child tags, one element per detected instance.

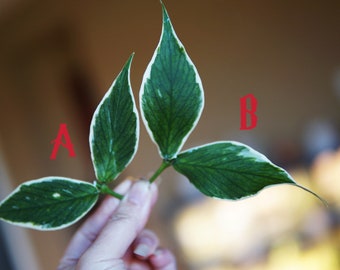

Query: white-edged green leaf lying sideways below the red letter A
<box><xmin>0</xmin><ymin>177</ymin><xmax>99</xmax><ymax>230</ymax></box>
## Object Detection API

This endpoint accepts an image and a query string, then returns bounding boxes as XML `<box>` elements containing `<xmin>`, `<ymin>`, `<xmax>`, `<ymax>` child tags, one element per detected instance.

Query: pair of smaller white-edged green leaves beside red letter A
<box><xmin>0</xmin><ymin>52</ymin><xmax>139</xmax><ymax>230</ymax></box>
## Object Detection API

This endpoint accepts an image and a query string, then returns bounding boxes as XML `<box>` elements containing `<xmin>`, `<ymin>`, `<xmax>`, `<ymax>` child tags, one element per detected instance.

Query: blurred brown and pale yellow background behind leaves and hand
<box><xmin>0</xmin><ymin>0</ymin><xmax>340</xmax><ymax>270</ymax></box>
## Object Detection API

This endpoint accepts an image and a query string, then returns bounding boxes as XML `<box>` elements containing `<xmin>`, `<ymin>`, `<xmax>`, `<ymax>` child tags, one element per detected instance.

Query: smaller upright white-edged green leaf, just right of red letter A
<box><xmin>90</xmin><ymin>55</ymin><xmax>139</xmax><ymax>182</ymax></box>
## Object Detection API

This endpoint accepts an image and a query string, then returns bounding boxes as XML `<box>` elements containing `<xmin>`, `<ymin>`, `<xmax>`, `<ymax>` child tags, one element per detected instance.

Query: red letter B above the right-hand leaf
<box><xmin>240</xmin><ymin>94</ymin><xmax>257</xmax><ymax>129</ymax></box>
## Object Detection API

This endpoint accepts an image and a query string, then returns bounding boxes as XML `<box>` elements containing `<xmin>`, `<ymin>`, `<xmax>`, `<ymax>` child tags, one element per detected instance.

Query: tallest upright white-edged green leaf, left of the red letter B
<box><xmin>140</xmin><ymin>2</ymin><xmax>204</xmax><ymax>160</ymax></box>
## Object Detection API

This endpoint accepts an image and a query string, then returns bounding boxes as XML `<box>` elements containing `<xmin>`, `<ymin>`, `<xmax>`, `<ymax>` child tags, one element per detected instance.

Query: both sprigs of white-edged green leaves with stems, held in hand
<box><xmin>0</xmin><ymin>3</ymin><xmax>325</xmax><ymax>230</ymax></box>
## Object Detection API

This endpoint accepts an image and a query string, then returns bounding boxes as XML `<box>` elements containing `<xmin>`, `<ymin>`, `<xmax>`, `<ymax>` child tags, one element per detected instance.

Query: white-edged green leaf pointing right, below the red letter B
<box><xmin>173</xmin><ymin>141</ymin><xmax>296</xmax><ymax>200</ymax></box>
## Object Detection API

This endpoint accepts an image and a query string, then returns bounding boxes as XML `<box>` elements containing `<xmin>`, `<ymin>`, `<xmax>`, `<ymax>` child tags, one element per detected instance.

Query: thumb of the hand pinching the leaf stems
<box><xmin>78</xmin><ymin>181</ymin><xmax>158</xmax><ymax>270</ymax></box>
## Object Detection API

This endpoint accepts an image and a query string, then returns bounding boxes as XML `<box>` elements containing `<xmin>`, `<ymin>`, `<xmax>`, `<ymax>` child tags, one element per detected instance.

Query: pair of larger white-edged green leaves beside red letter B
<box><xmin>140</xmin><ymin>3</ymin><xmax>302</xmax><ymax>199</ymax></box>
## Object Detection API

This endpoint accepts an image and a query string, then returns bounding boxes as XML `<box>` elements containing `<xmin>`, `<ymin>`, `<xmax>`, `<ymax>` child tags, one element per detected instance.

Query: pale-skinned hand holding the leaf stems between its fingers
<box><xmin>58</xmin><ymin>180</ymin><xmax>176</xmax><ymax>270</ymax></box>
